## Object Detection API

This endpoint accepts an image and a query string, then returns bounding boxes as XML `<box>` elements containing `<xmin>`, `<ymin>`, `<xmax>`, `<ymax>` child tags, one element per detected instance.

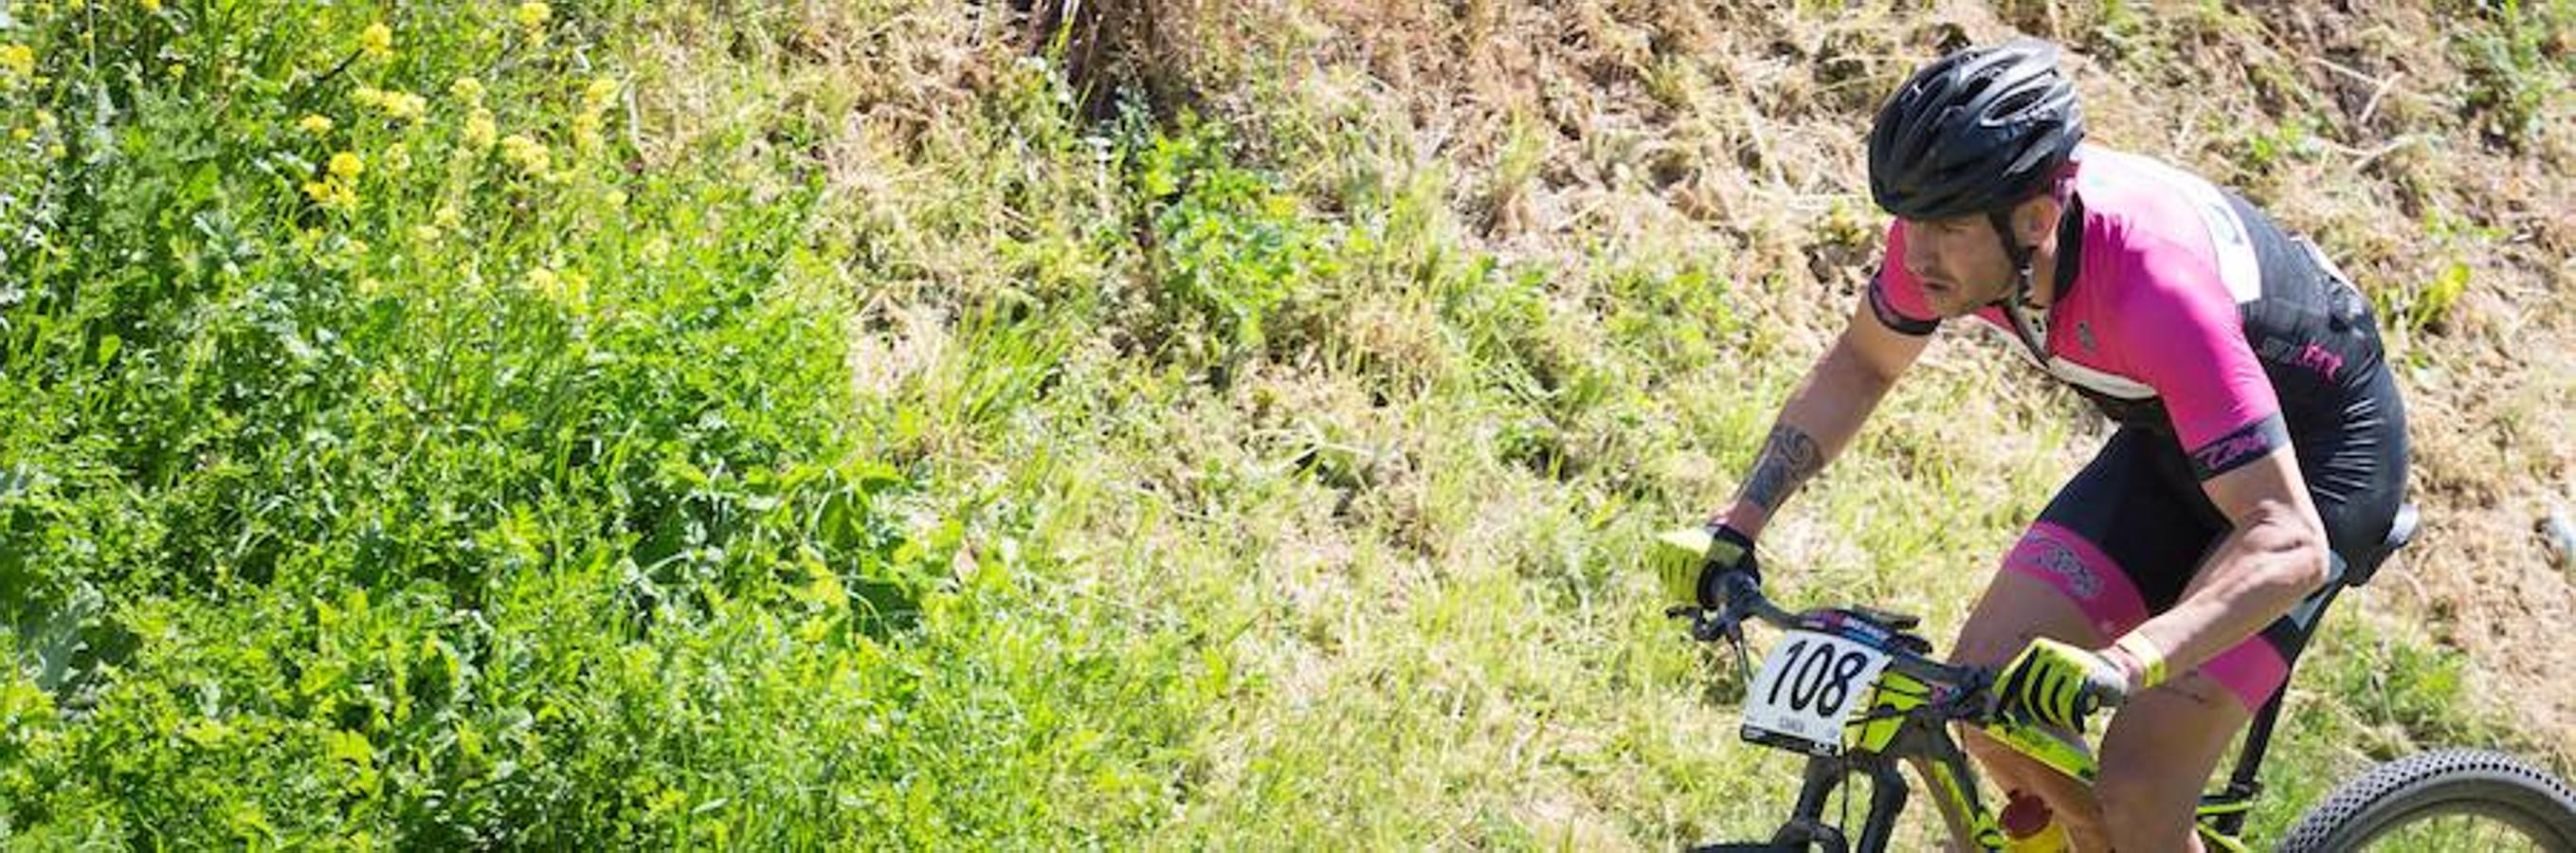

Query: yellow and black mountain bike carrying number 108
<box><xmin>1657</xmin><ymin>508</ymin><xmax>2576</xmax><ymax>853</ymax></box>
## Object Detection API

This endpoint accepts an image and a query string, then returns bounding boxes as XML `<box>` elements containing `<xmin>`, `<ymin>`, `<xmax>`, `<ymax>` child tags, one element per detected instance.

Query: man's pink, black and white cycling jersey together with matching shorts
<box><xmin>1868</xmin><ymin>147</ymin><xmax>2406</xmax><ymax>709</ymax></box>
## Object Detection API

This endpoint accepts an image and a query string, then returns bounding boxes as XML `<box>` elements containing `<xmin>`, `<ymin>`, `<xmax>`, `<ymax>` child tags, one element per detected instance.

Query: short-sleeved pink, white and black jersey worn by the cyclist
<box><xmin>1868</xmin><ymin>147</ymin><xmax>2380</xmax><ymax>480</ymax></box>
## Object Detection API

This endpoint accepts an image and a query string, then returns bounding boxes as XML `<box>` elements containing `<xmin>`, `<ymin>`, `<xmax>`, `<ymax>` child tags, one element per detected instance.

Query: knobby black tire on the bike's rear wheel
<box><xmin>2279</xmin><ymin>750</ymin><xmax>2576</xmax><ymax>853</ymax></box>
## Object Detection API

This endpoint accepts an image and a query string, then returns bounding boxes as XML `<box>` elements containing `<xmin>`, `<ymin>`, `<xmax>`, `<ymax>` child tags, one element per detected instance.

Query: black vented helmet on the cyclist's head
<box><xmin>1870</xmin><ymin>39</ymin><xmax>2084</xmax><ymax>219</ymax></box>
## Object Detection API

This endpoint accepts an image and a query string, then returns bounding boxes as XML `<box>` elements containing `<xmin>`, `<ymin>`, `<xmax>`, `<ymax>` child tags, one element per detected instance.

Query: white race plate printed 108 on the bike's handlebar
<box><xmin>1739</xmin><ymin>631</ymin><xmax>1888</xmax><ymax>755</ymax></box>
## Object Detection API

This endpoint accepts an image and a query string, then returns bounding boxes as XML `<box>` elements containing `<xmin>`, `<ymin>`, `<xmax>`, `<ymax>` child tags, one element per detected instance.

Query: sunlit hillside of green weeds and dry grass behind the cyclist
<box><xmin>0</xmin><ymin>0</ymin><xmax>2576</xmax><ymax>848</ymax></box>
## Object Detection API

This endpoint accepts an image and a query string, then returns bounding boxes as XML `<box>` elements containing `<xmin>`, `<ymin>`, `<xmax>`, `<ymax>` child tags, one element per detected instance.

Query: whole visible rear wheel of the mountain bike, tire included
<box><xmin>2282</xmin><ymin>750</ymin><xmax>2576</xmax><ymax>853</ymax></box>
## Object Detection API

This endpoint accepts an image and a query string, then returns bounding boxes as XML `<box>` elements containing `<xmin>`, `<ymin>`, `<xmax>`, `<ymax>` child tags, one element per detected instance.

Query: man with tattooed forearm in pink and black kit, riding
<box><xmin>1695</xmin><ymin>42</ymin><xmax>2406</xmax><ymax>850</ymax></box>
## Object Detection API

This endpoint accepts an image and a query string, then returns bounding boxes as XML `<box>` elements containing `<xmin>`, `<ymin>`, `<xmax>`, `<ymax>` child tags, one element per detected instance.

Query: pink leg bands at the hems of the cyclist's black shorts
<box><xmin>2005</xmin><ymin>520</ymin><xmax>2290</xmax><ymax>711</ymax></box>
